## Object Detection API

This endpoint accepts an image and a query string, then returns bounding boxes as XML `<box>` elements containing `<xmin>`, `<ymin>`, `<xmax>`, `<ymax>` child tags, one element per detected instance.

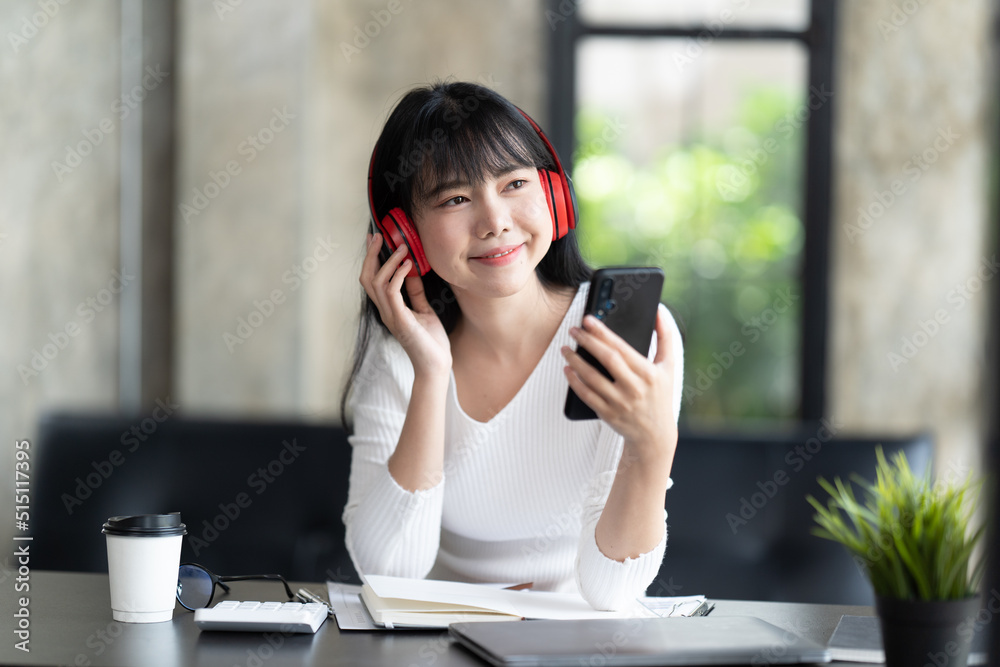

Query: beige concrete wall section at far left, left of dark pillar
<box><xmin>0</xmin><ymin>0</ymin><xmax>122</xmax><ymax>540</ymax></box>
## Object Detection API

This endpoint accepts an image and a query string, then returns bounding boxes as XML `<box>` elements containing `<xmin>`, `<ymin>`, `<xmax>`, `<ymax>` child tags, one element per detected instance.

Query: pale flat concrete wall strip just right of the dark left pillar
<box><xmin>175</xmin><ymin>0</ymin><xmax>310</xmax><ymax>414</ymax></box>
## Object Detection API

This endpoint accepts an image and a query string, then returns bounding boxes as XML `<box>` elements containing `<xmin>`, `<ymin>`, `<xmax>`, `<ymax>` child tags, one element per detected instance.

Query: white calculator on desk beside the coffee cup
<box><xmin>194</xmin><ymin>600</ymin><xmax>328</xmax><ymax>633</ymax></box>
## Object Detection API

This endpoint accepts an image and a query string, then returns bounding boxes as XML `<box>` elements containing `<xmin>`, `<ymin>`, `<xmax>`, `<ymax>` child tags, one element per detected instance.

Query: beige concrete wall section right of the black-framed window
<box><xmin>829</xmin><ymin>0</ymin><xmax>998</xmax><ymax>474</ymax></box>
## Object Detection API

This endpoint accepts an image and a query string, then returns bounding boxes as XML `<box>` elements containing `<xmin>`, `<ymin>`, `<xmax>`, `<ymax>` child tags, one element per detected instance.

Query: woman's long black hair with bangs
<box><xmin>340</xmin><ymin>82</ymin><xmax>593</xmax><ymax>426</ymax></box>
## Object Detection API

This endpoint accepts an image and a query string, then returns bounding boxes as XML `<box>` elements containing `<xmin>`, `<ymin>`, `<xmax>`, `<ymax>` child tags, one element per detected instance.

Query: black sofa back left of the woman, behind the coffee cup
<box><xmin>32</xmin><ymin>412</ymin><xmax>358</xmax><ymax>582</ymax></box>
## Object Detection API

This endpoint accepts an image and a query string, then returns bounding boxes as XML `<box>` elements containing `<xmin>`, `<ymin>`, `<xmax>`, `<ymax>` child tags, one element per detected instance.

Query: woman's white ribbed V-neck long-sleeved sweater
<box><xmin>344</xmin><ymin>284</ymin><xmax>683</xmax><ymax>609</ymax></box>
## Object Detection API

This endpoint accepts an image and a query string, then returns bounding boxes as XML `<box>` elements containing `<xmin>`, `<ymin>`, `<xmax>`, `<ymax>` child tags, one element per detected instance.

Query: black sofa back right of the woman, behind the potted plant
<box><xmin>647</xmin><ymin>424</ymin><xmax>934</xmax><ymax>604</ymax></box>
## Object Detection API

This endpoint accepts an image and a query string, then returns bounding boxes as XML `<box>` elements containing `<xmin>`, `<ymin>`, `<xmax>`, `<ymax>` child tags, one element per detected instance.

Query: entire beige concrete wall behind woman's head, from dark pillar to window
<box><xmin>177</xmin><ymin>0</ymin><xmax>547</xmax><ymax>417</ymax></box>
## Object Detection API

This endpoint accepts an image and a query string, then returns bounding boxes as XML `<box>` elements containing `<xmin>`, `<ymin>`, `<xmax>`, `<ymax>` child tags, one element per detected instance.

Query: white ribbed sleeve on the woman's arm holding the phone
<box><xmin>576</xmin><ymin>306</ymin><xmax>684</xmax><ymax>610</ymax></box>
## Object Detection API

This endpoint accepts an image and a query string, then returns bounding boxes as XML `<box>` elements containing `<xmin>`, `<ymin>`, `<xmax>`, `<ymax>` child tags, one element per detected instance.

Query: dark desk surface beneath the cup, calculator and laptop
<box><xmin>0</xmin><ymin>571</ymin><xmax>872</xmax><ymax>667</ymax></box>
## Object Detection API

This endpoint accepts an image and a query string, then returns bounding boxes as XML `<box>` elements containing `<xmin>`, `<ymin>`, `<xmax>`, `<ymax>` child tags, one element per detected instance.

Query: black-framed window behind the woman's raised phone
<box><xmin>546</xmin><ymin>0</ymin><xmax>833</xmax><ymax>423</ymax></box>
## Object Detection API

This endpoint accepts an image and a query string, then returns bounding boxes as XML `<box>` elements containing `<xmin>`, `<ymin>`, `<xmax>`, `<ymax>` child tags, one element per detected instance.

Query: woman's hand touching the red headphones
<box><xmin>361</xmin><ymin>234</ymin><xmax>451</xmax><ymax>374</ymax></box>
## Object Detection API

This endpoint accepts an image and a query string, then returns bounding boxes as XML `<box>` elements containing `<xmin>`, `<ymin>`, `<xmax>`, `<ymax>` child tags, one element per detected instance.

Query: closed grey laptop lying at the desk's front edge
<box><xmin>449</xmin><ymin>616</ymin><xmax>830</xmax><ymax>667</ymax></box>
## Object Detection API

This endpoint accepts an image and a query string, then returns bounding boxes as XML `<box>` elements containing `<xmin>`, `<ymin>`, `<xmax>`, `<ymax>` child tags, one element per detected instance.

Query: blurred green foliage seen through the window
<box><xmin>573</xmin><ymin>89</ymin><xmax>808</xmax><ymax>422</ymax></box>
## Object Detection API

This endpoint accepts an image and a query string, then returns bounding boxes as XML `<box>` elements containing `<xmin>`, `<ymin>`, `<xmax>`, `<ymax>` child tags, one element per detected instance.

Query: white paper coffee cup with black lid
<box><xmin>103</xmin><ymin>512</ymin><xmax>187</xmax><ymax>623</ymax></box>
